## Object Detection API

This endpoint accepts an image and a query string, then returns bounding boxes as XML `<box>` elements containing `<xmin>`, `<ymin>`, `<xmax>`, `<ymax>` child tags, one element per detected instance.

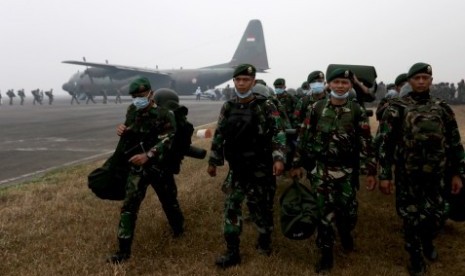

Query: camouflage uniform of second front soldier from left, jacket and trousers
<box><xmin>209</xmin><ymin>96</ymin><xmax>286</xmax><ymax>254</ymax></box>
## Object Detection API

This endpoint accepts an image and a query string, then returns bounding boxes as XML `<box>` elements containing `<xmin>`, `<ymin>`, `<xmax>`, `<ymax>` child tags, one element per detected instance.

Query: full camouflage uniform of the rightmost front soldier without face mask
<box><xmin>377</xmin><ymin>92</ymin><xmax>465</xmax><ymax>268</ymax></box>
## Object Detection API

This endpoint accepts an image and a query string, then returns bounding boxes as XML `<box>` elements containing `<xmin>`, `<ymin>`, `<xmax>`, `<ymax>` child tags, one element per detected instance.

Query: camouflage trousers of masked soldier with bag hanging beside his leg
<box><xmin>309</xmin><ymin>162</ymin><xmax>358</xmax><ymax>249</ymax></box>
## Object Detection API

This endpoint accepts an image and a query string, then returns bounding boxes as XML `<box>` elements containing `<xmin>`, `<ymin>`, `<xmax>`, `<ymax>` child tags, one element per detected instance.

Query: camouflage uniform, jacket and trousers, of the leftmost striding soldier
<box><xmin>118</xmin><ymin>105</ymin><xmax>184</xmax><ymax>242</ymax></box>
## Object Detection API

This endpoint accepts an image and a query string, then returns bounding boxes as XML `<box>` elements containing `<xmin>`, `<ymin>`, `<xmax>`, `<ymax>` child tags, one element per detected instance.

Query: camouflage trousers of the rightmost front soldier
<box><xmin>396</xmin><ymin>172</ymin><xmax>446</xmax><ymax>254</ymax></box>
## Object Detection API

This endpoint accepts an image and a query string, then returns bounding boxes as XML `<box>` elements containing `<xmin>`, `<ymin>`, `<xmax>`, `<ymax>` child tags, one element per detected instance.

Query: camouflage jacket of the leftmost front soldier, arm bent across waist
<box><xmin>123</xmin><ymin>104</ymin><xmax>176</xmax><ymax>164</ymax></box>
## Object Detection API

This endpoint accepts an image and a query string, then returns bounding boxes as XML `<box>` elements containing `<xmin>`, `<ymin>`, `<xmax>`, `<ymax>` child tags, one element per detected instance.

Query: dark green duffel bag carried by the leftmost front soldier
<box><xmin>87</xmin><ymin>156</ymin><xmax>129</xmax><ymax>200</ymax></box>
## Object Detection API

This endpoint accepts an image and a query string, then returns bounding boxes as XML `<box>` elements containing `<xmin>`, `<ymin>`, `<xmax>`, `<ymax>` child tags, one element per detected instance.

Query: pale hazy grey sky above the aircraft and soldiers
<box><xmin>0</xmin><ymin>0</ymin><xmax>465</xmax><ymax>95</ymax></box>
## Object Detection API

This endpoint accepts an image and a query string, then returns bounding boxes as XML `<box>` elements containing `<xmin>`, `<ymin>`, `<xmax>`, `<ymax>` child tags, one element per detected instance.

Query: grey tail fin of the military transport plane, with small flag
<box><xmin>229</xmin><ymin>19</ymin><xmax>269</xmax><ymax>72</ymax></box>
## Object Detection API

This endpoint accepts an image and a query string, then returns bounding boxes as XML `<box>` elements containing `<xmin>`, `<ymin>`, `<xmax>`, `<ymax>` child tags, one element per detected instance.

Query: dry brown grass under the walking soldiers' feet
<box><xmin>0</xmin><ymin>107</ymin><xmax>465</xmax><ymax>276</ymax></box>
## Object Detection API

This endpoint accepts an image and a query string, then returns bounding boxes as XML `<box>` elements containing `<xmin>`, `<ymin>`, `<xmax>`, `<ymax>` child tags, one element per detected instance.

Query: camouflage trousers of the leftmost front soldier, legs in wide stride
<box><xmin>118</xmin><ymin>167</ymin><xmax>184</xmax><ymax>239</ymax></box>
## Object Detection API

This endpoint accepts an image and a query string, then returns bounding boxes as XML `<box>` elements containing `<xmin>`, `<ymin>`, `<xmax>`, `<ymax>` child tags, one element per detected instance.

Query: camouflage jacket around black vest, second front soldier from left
<box><xmin>208</xmin><ymin>97</ymin><xmax>286</xmax><ymax>166</ymax></box>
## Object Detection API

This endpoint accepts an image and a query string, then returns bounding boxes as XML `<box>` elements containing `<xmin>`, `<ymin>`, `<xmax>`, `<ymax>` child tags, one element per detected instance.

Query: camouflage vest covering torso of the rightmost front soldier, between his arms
<box><xmin>395</xmin><ymin>98</ymin><xmax>446</xmax><ymax>173</ymax></box>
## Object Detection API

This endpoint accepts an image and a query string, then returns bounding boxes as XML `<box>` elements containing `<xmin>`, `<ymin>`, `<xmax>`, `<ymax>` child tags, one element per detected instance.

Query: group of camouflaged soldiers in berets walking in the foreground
<box><xmin>99</xmin><ymin>62</ymin><xmax>465</xmax><ymax>275</ymax></box>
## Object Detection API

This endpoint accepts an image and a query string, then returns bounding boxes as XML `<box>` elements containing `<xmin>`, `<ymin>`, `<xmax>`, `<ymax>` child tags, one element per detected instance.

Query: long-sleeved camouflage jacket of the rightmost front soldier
<box><xmin>376</xmin><ymin>93</ymin><xmax>465</xmax><ymax>180</ymax></box>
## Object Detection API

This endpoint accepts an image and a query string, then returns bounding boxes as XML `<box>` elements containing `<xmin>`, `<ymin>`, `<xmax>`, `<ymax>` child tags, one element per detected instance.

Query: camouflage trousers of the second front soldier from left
<box><xmin>222</xmin><ymin>166</ymin><xmax>276</xmax><ymax>236</ymax></box>
